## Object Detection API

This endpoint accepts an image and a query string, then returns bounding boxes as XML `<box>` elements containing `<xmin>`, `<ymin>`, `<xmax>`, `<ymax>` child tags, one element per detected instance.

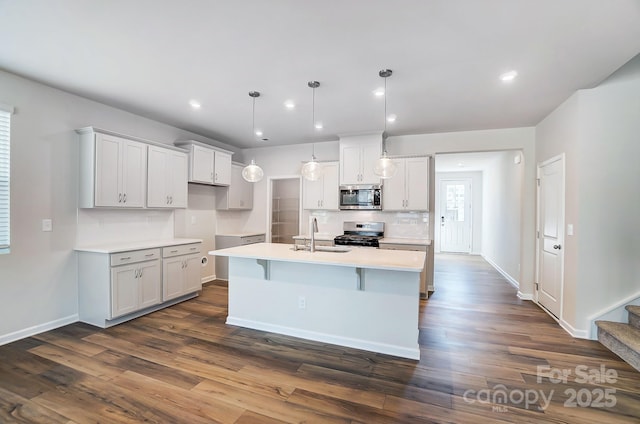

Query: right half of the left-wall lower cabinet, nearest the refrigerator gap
<box><xmin>162</xmin><ymin>244</ymin><xmax>202</xmax><ymax>301</ymax></box>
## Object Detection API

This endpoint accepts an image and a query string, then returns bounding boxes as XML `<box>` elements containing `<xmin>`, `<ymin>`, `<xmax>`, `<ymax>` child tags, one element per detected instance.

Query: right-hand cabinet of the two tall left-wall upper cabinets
<box><xmin>147</xmin><ymin>146</ymin><xmax>188</xmax><ymax>208</ymax></box>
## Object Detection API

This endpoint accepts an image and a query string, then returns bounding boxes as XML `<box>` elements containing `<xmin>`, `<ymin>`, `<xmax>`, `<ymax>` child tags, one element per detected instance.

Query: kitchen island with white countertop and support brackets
<box><xmin>209</xmin><ymin>243</ymin><xmax>425</xmax><ymax>359</ymax></box>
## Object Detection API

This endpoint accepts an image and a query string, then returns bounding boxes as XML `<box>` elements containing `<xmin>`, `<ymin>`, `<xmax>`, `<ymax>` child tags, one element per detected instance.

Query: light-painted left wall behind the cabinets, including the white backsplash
<box><xmin>0</xmin><ymin>71</ymin><xmax>232</xmax><ymax>344</ymax></box>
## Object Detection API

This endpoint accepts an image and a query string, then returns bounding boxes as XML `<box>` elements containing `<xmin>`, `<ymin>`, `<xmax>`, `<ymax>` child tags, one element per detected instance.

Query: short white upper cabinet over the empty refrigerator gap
<box><xmin>174</xmin><ymin>140</ymin><xmax>233</xmax><ymax>186</ymax></box>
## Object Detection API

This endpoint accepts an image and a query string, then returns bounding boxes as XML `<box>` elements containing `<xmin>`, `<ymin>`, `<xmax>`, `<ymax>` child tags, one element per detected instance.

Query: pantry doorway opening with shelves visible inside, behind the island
<box><xmin>269</xmin><ymin>177</ymin><xmax>301</xmax><ymax>244</ymax></box>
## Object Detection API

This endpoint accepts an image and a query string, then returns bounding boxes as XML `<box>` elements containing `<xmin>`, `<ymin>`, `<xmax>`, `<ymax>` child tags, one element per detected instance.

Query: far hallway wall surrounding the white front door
<box><xmin>433</xmin><ymin>170</ymin><xmax>484</xmax><ymax>255</ymax></box>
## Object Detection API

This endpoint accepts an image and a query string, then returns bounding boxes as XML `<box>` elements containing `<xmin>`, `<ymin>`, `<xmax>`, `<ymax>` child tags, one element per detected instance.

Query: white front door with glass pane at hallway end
<box><xmin>440</xmin><ymin>179</ymin><xmax>471</xmax><ymax>253</ymax></box>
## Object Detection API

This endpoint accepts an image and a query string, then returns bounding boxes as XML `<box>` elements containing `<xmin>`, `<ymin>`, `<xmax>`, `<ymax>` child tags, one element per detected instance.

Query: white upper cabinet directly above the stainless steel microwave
<box><xmin>340</xmin><ymin>134</ymin><xmax>382</xmax><ymax>185</ymax></box>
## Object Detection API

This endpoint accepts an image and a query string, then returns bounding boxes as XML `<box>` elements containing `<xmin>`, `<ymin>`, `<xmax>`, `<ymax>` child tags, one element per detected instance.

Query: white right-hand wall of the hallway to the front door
<box><xmin>482</xmin><ymin>152</ymin><xmax>524</xmax><ymax>287</ymax></box>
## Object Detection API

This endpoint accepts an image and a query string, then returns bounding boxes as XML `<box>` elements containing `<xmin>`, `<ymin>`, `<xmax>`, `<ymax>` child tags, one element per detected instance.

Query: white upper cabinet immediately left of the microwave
<box><xmin>302</xmin><ymin>162</ymin><xmax>339</xmax><ymax>210</ymax></box>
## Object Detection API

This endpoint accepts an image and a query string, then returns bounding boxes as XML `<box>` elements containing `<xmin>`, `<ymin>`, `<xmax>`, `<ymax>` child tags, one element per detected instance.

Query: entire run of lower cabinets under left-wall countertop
<box><xmin>77</xmin><ymin>243</ymin><xmax>202</xmax><ymax>328</ymax></box>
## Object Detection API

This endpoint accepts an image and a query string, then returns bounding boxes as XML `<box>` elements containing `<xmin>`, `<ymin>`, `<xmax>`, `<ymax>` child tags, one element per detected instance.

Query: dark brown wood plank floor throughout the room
<box><xmin>0</xmin><ymin>255</ymin><xmax>640</xmax><ymax>424</ymax></box>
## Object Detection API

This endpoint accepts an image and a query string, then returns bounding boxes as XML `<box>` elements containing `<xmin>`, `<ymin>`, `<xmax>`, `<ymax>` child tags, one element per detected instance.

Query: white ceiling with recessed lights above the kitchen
<box><xmin>0</xmin><ymin>0</ymin><xmax>640</xmax><ymax>148</ymax></box>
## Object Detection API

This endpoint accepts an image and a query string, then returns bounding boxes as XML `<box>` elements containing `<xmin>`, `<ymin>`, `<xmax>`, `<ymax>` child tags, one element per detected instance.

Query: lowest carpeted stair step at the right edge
<box><xmin>596</xmin><ymin>321</ymin><xmax>640</xmax><ymax>371</ymax></box>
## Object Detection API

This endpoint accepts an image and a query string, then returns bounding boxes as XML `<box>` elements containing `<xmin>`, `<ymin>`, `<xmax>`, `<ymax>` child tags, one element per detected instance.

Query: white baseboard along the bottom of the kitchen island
<box><xmin>227</xmin><ymin>316</ymin><xmax>420</xmax><ymax>360</ymax></box>
